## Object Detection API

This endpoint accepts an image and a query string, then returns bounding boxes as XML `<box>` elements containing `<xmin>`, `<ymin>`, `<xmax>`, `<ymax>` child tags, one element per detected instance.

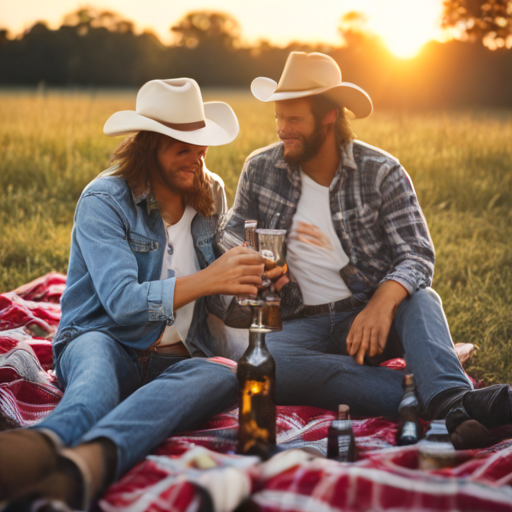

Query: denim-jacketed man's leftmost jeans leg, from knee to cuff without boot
<box><xmin>35</xmin><ymin>332</ymin><xmax>140</xmax><ymax>446</ymax></box>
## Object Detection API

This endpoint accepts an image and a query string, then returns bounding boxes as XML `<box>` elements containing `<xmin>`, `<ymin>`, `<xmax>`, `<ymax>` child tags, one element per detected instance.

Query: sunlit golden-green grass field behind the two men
<box><xmin>0</xmin><ymin>91</ymin><xmax>512</xmax><ymax>383</ymax></box>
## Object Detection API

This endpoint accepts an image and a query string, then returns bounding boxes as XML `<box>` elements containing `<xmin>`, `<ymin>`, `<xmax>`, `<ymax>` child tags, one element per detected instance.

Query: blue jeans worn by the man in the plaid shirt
<box><xmin>267</xmin><ymin>288</ymin><xmax>472</xmax><ymax>418</ymax></box>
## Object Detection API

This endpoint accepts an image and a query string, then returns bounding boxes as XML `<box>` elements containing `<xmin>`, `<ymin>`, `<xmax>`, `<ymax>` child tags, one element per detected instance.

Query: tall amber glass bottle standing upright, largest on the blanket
<box><xmin>237</xmin><ymin>328</ymin><xmax>276</xmax><ymax>454</ymax></box>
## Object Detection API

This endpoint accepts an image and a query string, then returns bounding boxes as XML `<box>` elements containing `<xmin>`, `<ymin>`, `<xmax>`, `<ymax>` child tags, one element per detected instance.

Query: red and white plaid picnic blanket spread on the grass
<box><xmin>0</xmin><ymin>273</ymin><xmax>512</xmax><ymax>512</ymax></box>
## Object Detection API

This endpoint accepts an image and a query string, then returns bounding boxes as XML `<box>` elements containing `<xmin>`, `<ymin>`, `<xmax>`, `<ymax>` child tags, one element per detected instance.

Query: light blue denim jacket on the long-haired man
<box><xmin>53</xmin><ymin>171</ymin><xmax>242</xmax><ymax>359</ymax></box>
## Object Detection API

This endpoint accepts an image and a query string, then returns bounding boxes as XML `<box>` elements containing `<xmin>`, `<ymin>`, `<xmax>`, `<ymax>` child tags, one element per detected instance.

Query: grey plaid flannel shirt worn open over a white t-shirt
<box><xmin>219</xmin><ymin>140</ymin><xmax>435</xmax><ymax>318</ymax></box>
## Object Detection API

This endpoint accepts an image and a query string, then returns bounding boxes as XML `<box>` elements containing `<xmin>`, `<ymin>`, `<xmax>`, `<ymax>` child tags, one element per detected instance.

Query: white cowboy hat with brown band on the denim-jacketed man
<box><xmin>103</xmin><ymin>78</ymin><xmax>239</xmax><ymax>146</ymax></box>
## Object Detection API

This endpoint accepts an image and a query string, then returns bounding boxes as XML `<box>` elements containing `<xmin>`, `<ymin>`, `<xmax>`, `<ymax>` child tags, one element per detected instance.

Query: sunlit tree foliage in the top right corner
<box><xmin>442</xmin><ymin>0</ymin><xmax>512</xmax><ymax>50</ymax></box>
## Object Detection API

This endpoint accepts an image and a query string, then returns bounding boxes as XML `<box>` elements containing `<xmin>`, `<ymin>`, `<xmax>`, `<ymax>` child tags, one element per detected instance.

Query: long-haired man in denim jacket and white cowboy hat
<box><xmin>0</xmin><ymin>78</ymin><xmax>263</xmax><ymax>510</ymax></box>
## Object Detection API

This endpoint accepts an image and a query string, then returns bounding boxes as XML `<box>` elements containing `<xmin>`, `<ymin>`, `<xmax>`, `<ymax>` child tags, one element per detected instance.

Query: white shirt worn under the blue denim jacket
<box><xmin>159</xmin><ymin>205</ymin><xmax>201</xmax><ymax>345</ymax></box>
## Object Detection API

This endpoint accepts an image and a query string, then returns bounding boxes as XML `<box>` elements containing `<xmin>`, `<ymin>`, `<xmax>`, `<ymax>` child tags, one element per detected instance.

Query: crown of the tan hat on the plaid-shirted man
<box><xmin>276</xmin><ymin>52</ymin><xmax>341</xmax><ymax>92</ymax></box>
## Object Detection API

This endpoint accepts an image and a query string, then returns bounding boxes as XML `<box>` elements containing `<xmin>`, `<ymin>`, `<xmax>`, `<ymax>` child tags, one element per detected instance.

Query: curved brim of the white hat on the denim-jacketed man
<box><xmin>103</xmin><ymin>101</ymin><xmax>240</xmax><ymax>146</ymax></box>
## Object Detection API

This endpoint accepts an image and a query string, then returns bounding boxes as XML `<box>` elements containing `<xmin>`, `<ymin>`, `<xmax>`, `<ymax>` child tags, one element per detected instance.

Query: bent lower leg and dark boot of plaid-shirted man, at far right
<box><xmin>395</xmin><ymin>288</ymin><xmax>512</xmax><ymax>449</ymax></box>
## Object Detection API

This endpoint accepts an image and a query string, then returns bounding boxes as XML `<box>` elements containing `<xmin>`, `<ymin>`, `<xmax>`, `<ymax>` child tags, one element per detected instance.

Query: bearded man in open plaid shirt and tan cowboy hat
<box><xmin>224</xmin><ymin>52</ymin><xmax>512</xmax><ymax>448</ymax></box>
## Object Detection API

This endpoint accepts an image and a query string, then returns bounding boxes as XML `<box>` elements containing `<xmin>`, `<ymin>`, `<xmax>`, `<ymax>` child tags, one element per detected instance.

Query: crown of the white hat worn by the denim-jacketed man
<box><xmin>135</xmin><ymin>78</ymin><xmax>205</xmax><ymax>125</ymax></box>
